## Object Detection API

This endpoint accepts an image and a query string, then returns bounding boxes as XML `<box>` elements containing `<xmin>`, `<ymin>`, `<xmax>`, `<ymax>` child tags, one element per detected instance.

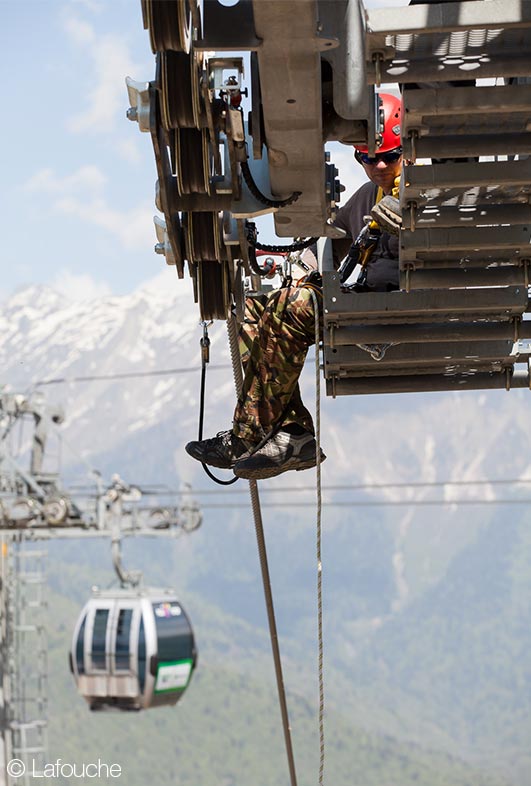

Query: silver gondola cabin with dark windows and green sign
<box><xmin>70</xmin><ymin>589</ymin><xmax>197</xmax><ymax>710</ymax></box>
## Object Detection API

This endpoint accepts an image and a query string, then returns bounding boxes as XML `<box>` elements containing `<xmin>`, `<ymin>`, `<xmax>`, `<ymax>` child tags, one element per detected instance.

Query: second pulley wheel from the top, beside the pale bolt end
<box><xmin>157</xmin><ymin>51</ymin><xmax>203</xmax><ymax>131</ymax></box>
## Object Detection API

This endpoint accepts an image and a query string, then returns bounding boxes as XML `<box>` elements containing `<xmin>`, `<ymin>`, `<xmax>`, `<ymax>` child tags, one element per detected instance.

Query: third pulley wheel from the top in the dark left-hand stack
<box><xmin>171</xmin><ymin>128</ymin><xmax>211</xmax><ymax>196</ymax></box>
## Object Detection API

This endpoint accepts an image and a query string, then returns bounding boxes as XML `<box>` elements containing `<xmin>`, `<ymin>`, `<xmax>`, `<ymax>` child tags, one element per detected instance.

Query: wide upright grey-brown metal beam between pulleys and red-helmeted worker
<box><xmin>253</xmin><ymin>0</ymin><xmax>327</xmax><ymax>237</ymax></box>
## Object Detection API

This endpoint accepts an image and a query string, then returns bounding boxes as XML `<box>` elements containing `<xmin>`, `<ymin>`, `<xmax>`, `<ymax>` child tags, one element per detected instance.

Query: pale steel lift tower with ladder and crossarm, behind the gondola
<box><xmin>0</xmin><ymin>392</ymin><xmax>201</xmax><ymax>786</ymax></box>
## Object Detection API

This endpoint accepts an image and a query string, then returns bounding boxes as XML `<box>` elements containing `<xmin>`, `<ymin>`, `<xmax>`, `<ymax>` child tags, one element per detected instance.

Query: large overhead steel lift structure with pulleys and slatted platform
<box><xmin>128</xmin><ymin>0</ymin><xmax>531</xmax><ymax>396</ymax></box>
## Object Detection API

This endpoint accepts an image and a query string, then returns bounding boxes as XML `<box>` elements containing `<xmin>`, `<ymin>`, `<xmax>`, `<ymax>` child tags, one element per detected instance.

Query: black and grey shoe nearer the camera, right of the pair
<box><xmin>234</xmin><ymin>431</ymin><xmax>326</xmax><ymax>480</ymax></box>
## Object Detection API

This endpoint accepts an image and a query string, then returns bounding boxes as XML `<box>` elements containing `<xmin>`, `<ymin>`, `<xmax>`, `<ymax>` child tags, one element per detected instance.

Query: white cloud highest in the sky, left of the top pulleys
<box><xmin>64</xmin><ymin>17</ymin><xmax>144</xmax><ymax>134</ymax></box>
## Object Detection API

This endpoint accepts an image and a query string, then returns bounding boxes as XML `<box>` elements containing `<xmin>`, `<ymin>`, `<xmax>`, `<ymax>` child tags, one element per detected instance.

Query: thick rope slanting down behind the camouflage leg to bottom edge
<box><xmin>227</xmin><ymin>316</ymin><xmax>297</xmax><ymax>786</ymax></box>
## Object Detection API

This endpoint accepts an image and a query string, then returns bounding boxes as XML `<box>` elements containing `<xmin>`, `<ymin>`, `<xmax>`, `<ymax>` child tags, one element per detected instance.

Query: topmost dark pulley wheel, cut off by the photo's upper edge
<box><xmin>142</xmin><ymin>0</ymin><xmax>194</xmax><ymax>52</ymax></box>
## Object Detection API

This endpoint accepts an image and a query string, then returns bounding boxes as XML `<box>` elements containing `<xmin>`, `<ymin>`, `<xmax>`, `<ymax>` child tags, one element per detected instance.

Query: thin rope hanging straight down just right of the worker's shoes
<box><xmin>310</xmin><ymin>289</ymin><xmax>325</xmax><ymax>786</ymax></box>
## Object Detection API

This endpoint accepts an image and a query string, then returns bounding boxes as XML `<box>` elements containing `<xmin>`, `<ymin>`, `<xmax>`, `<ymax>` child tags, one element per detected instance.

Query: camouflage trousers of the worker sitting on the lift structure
<box><xmin>233</xmin><ymin>286</ymin><xmax>322</xmax><ymax>442</ymax></box>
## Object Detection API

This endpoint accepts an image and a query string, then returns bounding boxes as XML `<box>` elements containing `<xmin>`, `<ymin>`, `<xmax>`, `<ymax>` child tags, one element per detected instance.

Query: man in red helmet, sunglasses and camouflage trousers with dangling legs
<box><xmin>185</xmin><ymin>93</ymin><xmax>402</xmax><ymax>480</ymax></box>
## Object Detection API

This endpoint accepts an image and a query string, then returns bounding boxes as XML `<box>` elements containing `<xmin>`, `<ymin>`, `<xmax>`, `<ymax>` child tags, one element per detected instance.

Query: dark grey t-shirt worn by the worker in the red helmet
<box><xmin>334</xmin><ymin>181</ymin><xmax>398</xmax><ymax>292</ymax></box>
